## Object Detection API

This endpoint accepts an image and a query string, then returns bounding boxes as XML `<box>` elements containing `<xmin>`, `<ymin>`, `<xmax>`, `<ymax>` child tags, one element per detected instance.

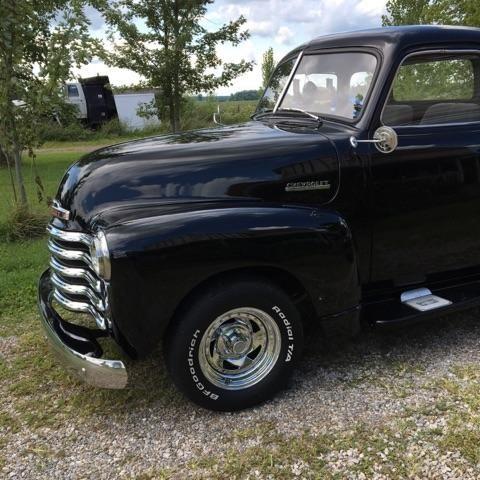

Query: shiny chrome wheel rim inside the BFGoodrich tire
<box><xmin>199</xmin><ymin>307</ymin><xmax>282</xmax><ymax>390</ymax></box>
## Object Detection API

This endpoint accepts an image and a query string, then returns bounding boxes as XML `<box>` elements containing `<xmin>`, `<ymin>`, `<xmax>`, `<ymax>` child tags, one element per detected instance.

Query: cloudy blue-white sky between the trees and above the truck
<box><xmin>74</xmin><ymin>0</ymin><xmax>386</xmax><ymax>95</ymax></box>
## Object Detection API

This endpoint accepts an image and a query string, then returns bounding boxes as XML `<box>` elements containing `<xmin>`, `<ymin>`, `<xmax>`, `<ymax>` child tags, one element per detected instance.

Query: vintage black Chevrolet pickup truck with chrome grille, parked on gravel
<box><xmin>39</xmin><ymin>26</ymin><xmax>480</xmax><ymax>410</ymax></box>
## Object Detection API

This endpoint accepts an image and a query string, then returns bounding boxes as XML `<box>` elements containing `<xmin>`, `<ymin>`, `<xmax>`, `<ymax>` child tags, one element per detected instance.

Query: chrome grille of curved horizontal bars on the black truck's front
<box><xmin>47</xmin><ymin>225</ymin><xmax>108</xmax><ymax>329</ymax></box>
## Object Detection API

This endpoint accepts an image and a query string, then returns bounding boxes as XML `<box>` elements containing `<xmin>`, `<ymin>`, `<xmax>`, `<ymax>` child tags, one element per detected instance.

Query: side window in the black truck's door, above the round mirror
<box><xmin>382</xmin><ymin>55</ymin><xmax>480</xmax><ymax>127</ymax></box>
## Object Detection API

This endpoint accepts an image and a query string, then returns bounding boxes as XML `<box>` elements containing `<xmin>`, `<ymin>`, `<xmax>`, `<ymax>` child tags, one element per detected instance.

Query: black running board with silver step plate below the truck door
<box><xmin>362</xmin><ymin>281</ymin><xmax>480</xmax><ymax>325</ymax></box>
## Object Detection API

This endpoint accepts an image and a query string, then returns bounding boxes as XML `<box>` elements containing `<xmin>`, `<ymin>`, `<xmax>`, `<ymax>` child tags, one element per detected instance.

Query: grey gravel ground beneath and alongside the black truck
<box><xmin>0</xmin><ymin>311</ymin><xmax>480</xmax><ymax>479</ymax></box>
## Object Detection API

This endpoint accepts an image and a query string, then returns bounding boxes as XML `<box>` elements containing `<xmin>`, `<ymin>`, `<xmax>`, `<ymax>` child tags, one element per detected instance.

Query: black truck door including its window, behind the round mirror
<box><xmin>371</xmin><ymin>51</ymin><xmax>480</xmax><ymax>285</ymax></box>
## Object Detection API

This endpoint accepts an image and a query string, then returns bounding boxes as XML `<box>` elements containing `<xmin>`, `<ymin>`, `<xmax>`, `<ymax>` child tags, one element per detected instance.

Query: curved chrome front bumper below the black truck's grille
<box><xmin>38</xmin><ymin>269</ymin><xmax>128</xmax><ymax>389</ymax></box>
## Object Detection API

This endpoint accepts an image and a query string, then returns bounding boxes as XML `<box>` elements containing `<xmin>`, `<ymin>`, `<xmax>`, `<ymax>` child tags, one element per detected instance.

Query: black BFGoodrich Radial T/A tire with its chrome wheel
<box><xmin>164</xmin><ymin>279</ymin><xmax>303</xmax><ymax>411</ymax></box>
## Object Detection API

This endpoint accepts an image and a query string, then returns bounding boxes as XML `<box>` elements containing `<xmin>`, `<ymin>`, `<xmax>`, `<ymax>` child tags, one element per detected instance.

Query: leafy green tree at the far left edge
<box><xmin>0</xmin><ymin>0</ymin><xmax>95</xmax><ymax>208</ymax></box>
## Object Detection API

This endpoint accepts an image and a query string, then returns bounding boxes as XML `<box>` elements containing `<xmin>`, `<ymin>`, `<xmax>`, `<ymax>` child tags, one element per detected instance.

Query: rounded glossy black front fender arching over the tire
<box><xmin>106</xmin><ymin>206</ymin><xmax>360</xmax><ymax>354</ymax></box>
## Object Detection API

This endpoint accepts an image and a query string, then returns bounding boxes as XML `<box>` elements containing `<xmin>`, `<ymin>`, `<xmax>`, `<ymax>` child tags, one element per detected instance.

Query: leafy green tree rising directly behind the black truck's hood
<box><xmin>102</xmin><ymin>0</ymin><xmax>253</xmax><ymax>131</ymax></box>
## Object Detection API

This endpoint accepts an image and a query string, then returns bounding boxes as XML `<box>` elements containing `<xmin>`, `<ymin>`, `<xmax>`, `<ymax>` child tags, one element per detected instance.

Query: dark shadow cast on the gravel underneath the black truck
<box><xmin>113</xmin><ymin>310</ymin><xmax>480</xmax><ymax>415</ymax></box>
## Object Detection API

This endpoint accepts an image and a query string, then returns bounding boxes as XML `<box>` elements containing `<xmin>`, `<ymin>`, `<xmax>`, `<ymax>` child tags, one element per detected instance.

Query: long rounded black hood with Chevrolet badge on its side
<box><xmin>57</xmin><ymin>121</ymin><xmax>339</xmax><ymax>228</ymax></box>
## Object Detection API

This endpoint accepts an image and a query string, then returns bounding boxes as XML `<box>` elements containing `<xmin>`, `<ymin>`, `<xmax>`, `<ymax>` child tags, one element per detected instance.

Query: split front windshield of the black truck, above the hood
<box><xmin>257</xmin><ymin>52</ymin><xmax>377</xmax><ymax>120</ymax></box>
